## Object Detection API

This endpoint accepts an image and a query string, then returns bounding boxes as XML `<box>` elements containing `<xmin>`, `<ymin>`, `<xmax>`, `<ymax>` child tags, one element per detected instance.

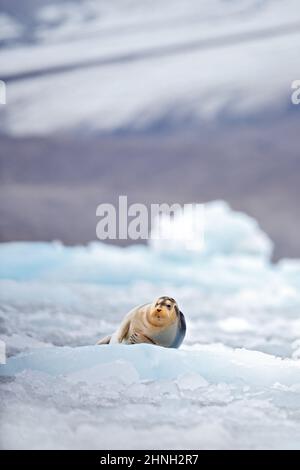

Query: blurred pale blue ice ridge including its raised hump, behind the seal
<box><xmin>0</xmin><ymin>201</ymin><xmax>274</xmax><ymax>288</ymax></box>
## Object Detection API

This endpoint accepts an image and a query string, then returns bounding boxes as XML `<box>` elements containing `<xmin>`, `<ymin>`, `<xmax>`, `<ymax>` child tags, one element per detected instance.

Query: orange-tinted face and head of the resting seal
<box><xmin>148</xmin><ymin>297</ymin><xmax>179</xmax><ymax>327</ymax></box>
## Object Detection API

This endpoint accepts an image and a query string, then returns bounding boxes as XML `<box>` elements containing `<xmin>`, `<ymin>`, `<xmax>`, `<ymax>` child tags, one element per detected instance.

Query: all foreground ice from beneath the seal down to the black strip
<box><xmin>1</xmin><ymin>345</ymin><xmax>300</xmax><ymax>449</ymax></box>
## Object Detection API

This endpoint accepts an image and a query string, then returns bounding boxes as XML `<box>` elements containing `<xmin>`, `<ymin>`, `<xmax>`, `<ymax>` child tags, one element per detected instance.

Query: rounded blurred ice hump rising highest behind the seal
<box><xmin>150</xmin><ymin>201</ymin><xmax>273</xmax><ymax>260</ymax></box>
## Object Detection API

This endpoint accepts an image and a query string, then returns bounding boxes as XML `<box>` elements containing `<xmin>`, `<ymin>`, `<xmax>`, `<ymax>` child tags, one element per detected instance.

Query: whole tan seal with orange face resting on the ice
<box><xmin>97</xmin><ymin>297</ymin><xmax>186</xmax><ymax>348</ymax></box>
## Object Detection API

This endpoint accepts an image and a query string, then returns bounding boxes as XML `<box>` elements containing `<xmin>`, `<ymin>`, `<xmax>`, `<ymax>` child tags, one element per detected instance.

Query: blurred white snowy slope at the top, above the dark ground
<box><xmin>0</xmin><ymin>0</ymin><xmax>300</xmax><ymax>135</ymax></box>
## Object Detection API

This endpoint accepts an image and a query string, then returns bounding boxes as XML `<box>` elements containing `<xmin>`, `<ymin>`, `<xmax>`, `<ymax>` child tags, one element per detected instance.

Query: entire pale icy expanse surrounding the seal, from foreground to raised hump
<box><xmin>0</xmin><ymin>202</ymin><xmax>300</xmax><ymax>449</ymax></box>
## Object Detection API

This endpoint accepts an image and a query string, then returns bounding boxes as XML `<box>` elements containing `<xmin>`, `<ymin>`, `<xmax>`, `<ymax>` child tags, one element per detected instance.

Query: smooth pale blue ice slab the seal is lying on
<box><xmin>0</xmin><ymin>345</ymin><xmax>300</xmax><ymax>387</ymax></box>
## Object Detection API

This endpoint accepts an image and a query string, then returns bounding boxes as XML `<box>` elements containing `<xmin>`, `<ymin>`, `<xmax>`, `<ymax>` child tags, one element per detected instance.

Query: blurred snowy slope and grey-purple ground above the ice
<box><xmin>0</xmin><ymin>0</ymin><xmax>300</xmax><ymax>259</ymax></box>
